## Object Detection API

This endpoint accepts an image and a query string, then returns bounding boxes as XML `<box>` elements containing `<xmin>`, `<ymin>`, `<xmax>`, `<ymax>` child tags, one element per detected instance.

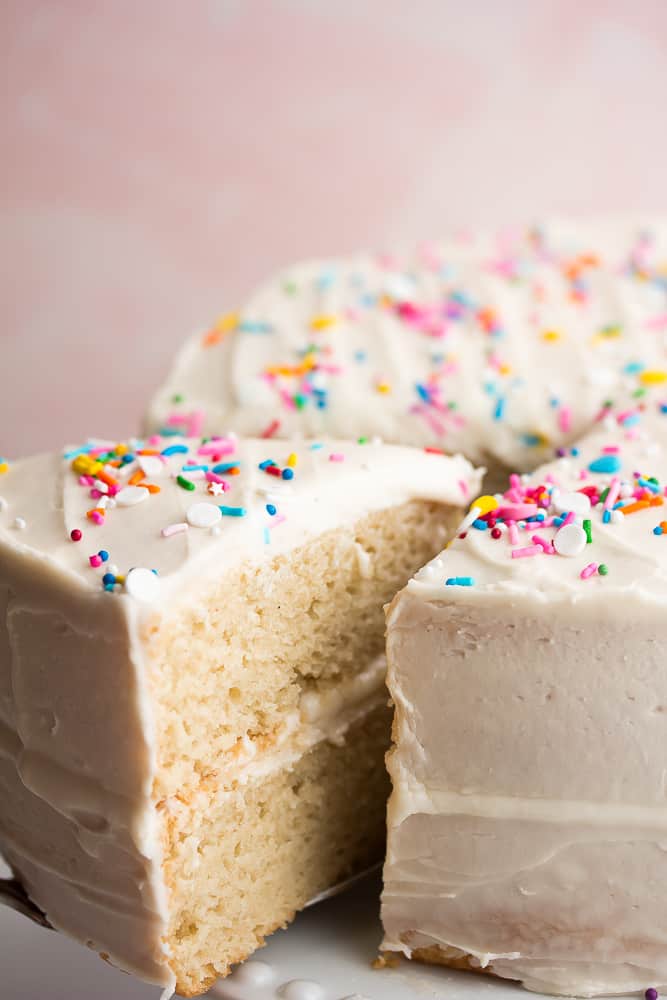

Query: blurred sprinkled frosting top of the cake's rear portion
<box><xmin>148</xmin><ymin>223</ymin><xmax>667</xmax><ymax>470</ymax></box>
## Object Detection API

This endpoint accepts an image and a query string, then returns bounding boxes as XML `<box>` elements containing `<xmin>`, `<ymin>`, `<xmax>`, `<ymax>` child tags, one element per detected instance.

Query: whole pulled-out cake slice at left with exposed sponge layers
<box><xmin>0</xmin><ymin>437</ymin><xmax>479</xmax><ymax>996</ymax></box>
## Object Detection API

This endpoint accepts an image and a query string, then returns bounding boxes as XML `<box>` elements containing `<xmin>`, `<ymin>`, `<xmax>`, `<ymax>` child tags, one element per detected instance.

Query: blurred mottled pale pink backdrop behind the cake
<box><xmin>0</xmin><ymin>0</ymin><xmax>667</xmax><ymax>456</ymax></box>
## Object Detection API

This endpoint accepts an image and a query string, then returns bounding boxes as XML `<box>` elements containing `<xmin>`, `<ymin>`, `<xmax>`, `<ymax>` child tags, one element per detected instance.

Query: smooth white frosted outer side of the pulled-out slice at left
<box><xmin>0</xmin><ymin>537</ymin><xmax>173</xmax><ymax>987</ymax></box>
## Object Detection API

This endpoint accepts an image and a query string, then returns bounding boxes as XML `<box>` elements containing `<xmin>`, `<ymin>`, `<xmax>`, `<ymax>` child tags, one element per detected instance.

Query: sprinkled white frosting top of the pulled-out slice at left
<box><xmin>0</xmin><ymin>435</ymin><xmax>480</xmax><ymax>600</ymax></box>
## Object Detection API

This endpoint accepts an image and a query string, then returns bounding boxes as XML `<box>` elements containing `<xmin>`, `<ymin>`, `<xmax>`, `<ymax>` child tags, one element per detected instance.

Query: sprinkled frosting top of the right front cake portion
<box><xmin>409</xmin><ymin>403</ymin><xmax>667</xmax><ymax>601</ymax></box>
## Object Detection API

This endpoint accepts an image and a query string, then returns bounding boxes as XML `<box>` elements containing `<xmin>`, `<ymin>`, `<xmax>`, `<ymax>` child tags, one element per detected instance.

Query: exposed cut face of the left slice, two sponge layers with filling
<box><xmin>147</xmin><ymin>501</ymin><xmax>458</xmax><ymax>995</ymax></box>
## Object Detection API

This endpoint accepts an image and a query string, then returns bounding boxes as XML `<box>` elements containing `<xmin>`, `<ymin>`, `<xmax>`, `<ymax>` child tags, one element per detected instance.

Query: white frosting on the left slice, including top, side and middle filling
<box><xmin>0</xmin><ymin>438</ymin><xmax>479</xmax><ymax>990</ymax></box>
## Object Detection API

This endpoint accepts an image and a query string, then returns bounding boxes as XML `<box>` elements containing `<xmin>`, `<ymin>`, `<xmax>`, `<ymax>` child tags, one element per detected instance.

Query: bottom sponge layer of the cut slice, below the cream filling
<box><xmin>164</xmin><ymin>697</ymin><xmax>390</xmax><ymax>996</ymax></box>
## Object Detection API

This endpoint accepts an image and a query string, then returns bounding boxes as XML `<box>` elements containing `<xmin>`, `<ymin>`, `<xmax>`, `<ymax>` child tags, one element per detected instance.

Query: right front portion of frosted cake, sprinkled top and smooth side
<box><xmin>383</xmin><ymin>403</ymin><xmax>667</xmax><ymax>996</ymax></box>
